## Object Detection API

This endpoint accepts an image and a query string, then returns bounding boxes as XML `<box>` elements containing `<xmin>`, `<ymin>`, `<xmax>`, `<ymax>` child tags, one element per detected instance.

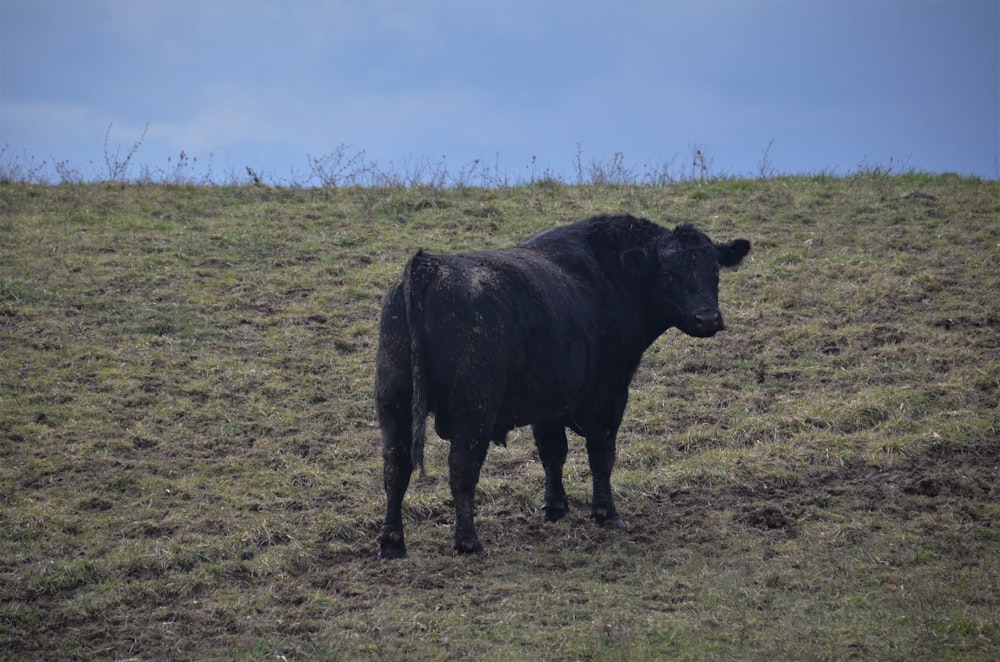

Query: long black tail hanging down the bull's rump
<box><xmin>403</xmin><ymin>251</ymin><xmax>437</xmax><ymax>476</ymax></box>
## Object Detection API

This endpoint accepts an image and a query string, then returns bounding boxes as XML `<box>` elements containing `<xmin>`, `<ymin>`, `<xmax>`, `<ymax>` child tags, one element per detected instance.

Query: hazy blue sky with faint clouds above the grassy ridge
<box><xmin>0</xmin><ymin>0</ymin><xmax>1000</xmax><ymax>183</ymax></box>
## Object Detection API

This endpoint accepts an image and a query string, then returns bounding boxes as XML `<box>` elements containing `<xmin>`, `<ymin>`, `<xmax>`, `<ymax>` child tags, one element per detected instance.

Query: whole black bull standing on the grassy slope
<box><xmin>375</xmin><ymin>216</ymin><xmax>750</xmax><ymax>558</ymax></box>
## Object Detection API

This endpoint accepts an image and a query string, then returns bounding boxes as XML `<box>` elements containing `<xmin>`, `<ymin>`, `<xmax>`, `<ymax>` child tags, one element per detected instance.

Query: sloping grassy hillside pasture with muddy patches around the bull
<box><xmin>0</xmin><ymin>174</ymin><xmax>1000</xmax><ymax>660</ymax></box>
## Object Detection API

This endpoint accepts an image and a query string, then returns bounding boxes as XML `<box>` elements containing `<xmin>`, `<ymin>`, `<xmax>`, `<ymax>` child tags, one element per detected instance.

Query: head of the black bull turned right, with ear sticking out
<box><xmin>657</xmin><ymin>225</ymin><xmax>750</xmax><ymax>338</ymax></box>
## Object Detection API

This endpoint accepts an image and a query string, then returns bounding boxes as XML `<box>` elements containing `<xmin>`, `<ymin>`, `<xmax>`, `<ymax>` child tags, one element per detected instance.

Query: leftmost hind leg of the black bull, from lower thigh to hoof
<box><xmin>378</xmin><ymin>410</ymin><xmax>413</xmax><ymax>559</ymax></box>
